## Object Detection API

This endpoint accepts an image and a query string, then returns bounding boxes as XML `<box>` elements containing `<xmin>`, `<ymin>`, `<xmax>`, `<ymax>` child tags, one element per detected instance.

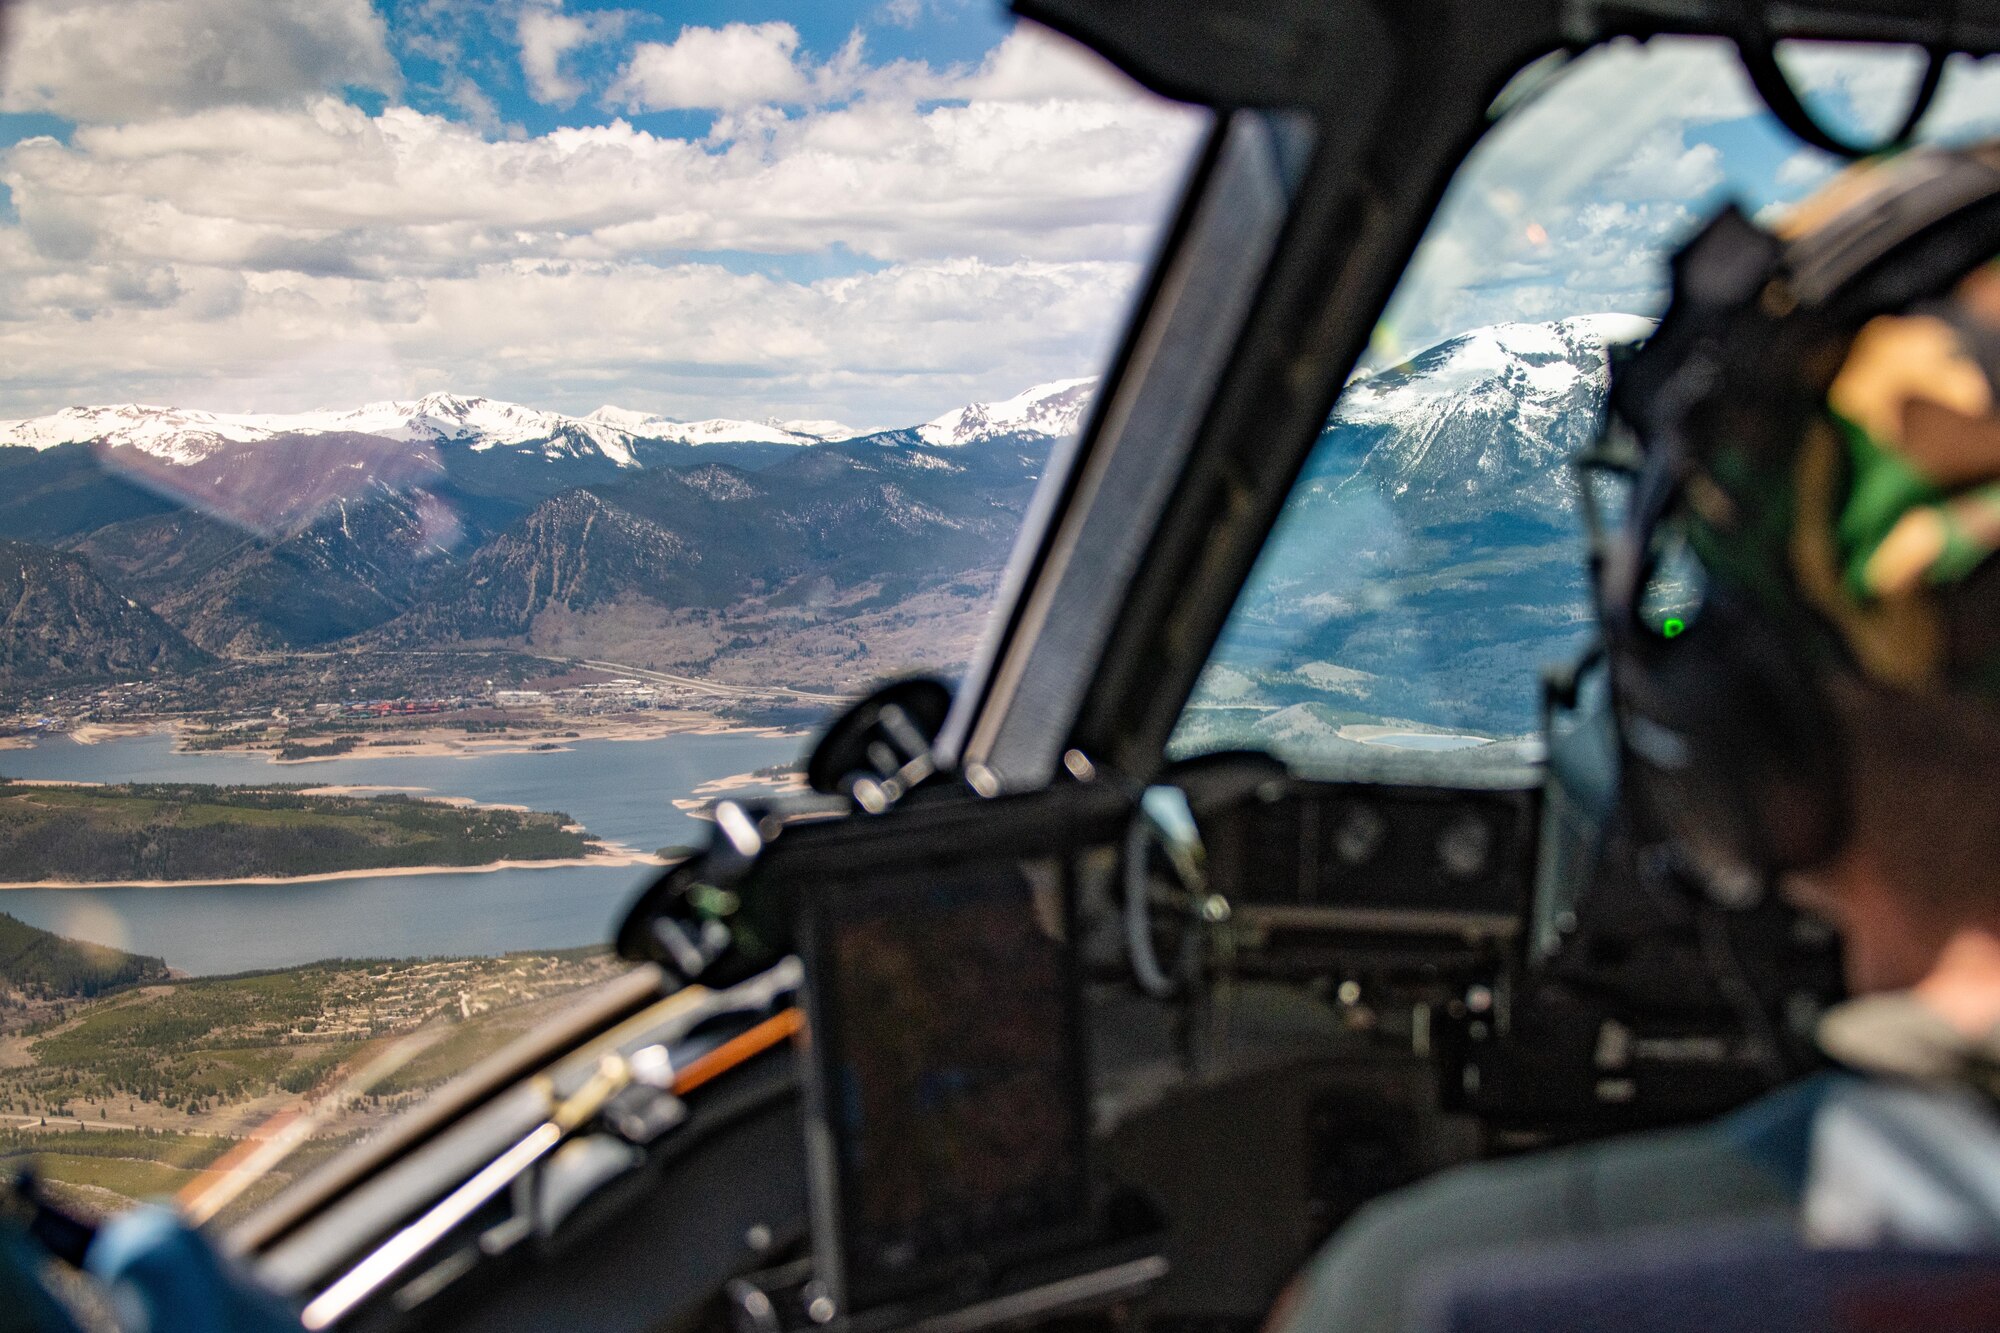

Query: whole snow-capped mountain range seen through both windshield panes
<box><xmin>0</xmin><ymin>316</ymin><xmax>1650</xmax><ymax>728</ymax></box>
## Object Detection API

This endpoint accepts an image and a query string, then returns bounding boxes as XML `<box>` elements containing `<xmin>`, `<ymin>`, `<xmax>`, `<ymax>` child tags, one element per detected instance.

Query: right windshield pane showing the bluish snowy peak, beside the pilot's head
<box><xmin>1172</xmin><ymin>38</ymin><xmax>2000</xmax><ymax>781</ymax></box>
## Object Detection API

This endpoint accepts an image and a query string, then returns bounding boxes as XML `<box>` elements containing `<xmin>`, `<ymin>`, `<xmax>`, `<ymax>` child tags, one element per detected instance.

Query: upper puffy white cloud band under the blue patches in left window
<box><xmin>0</xmin><ymin>72</ymin><xmax>1196</xmax><ymax>276</ymax></box>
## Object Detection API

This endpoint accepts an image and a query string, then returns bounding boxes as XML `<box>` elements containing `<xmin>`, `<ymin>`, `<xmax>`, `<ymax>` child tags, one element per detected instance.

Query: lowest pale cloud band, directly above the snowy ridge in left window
<box><xmin>0</xmin><ymin>252</ymin><xmax>1138</xmax><ymax>424</ymax></box>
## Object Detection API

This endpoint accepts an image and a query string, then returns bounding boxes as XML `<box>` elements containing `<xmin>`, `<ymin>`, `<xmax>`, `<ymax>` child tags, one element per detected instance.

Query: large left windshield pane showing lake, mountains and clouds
<box><xmin>0</xmin><ymin>0</ymin><xmax>1206</xmax><ymax>1209</ymax></box>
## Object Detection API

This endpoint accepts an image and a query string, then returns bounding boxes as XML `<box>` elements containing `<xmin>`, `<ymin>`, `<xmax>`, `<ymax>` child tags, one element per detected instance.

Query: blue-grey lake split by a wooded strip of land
<box><xmin>0</xmin><ymin>733</ymin><xmax>810</xmax><ymax>975</ymax></box>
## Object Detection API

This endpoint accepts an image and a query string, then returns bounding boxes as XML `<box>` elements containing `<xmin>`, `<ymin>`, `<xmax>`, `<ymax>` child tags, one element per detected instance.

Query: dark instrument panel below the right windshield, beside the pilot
<box><xmin>1186</xmin><ymin>763</ymin><xmax>1838</xmax><ymax>1135</ymax></box>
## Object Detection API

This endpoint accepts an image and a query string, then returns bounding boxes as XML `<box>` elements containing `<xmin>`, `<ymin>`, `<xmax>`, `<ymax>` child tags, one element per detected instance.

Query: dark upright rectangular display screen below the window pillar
<box><xmin>808</xmin><ymin>863</ymin><xmax>1088</xmax><ymax>1309</ymax></box>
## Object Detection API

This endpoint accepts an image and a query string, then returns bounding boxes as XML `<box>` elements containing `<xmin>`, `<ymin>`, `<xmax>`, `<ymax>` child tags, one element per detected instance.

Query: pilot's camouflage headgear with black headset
<box><xmin>1600</xmin><ymin>142</ymin><xmax>2000</xmax><ymax>897</ymax></box>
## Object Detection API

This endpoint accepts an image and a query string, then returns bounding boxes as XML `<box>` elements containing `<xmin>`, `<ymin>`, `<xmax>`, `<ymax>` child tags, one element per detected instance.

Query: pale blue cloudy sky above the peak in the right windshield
<box><xmin>1374</xmin><ymin>38</ymin><xmax>2000</xmax><ymax>362</ymax></box>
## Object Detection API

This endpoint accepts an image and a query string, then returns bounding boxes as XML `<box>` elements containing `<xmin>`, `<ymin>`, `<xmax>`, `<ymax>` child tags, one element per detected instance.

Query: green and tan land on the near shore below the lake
<box><xmin>0</xmin><ymin>949</ymin><xmax>626</xmax><ymax>1215</ymax></box>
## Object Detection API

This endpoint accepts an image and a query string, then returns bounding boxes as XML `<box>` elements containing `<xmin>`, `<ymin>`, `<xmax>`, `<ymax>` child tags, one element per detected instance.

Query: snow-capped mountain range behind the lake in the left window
<box><xmin>0</xmin><ymin>380</ymin><xmax>1094</xmax><ymax>688</ymax></box>
